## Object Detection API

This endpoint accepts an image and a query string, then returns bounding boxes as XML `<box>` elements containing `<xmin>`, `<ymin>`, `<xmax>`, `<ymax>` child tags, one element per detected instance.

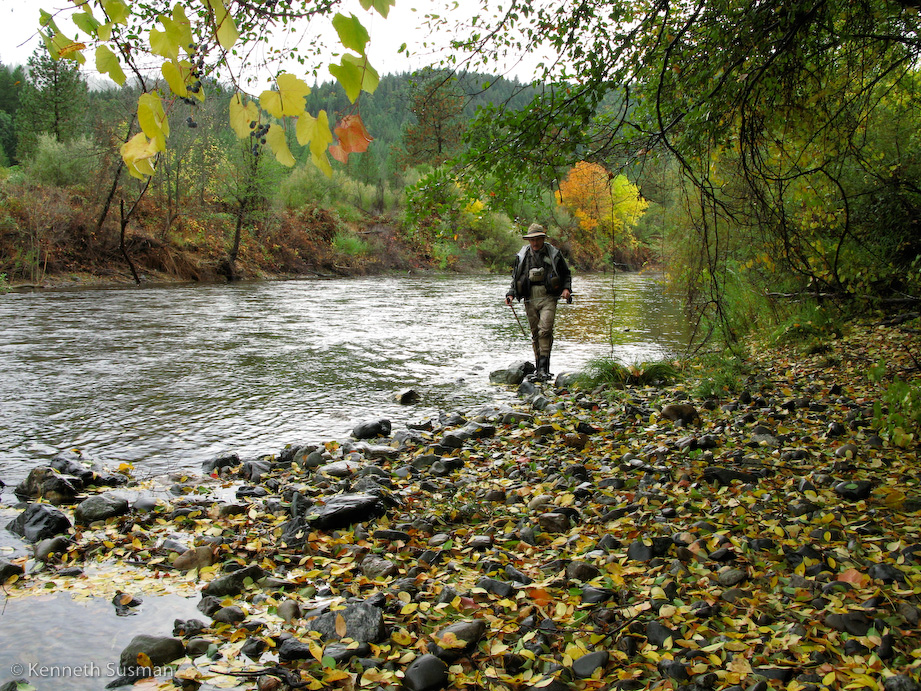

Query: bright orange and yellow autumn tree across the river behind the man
<box><xmin>557</xmin><ymin>161</ymin><xmax>649</xmax><ymax>258</ymax></box>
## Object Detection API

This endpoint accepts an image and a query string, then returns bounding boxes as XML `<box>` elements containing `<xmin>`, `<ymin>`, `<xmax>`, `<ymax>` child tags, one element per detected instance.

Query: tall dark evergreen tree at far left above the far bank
<box><xmin>15</xmin><ymin>48</ymin><xmax>89</xmax><ymax>160</ymax></box>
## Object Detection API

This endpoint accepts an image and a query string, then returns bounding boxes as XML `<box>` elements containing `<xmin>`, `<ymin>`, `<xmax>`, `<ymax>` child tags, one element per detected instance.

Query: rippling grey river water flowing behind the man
<box><xmin>0</xmin><ymin>274</ymin><xmax>686</xmax><ymax>485</ymax></box>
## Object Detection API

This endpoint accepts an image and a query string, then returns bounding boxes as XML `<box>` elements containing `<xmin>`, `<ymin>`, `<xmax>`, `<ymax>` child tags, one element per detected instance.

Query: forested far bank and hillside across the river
<box><xmin>0</xmin><ymin>53</ymin><xmax>652</xmax><ymax>290</ymax></box>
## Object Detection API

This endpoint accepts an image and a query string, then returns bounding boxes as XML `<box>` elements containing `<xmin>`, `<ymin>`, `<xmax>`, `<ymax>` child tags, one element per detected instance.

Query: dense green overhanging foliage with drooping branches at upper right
<box><xmin>455</xmin><ymin>0</ymin><xmax>921</xmax><ymax>336</ymax></box>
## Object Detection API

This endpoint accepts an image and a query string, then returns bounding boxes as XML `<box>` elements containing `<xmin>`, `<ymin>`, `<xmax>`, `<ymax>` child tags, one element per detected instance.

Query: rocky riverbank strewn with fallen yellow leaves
<box><xmin>0</xmin><ymin>318</ymin><xmax>921</xmax><ymax>691</ymax></box>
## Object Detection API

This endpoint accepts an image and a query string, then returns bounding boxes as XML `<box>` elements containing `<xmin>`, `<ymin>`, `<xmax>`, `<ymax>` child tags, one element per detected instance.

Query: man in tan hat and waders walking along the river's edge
<box><xmin>505</xmin><ymin>223</ymin><xmax>572</xmax><ymax>381</ymax></box>
